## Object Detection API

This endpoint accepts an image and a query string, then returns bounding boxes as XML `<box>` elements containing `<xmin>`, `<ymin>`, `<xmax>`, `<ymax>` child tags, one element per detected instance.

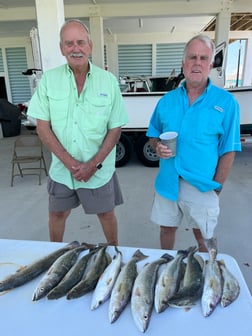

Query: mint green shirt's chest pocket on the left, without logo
<box><xmin>48</xmin><ymin>90</ymin><xmax>69</xmax><ymax>126</ymax></box>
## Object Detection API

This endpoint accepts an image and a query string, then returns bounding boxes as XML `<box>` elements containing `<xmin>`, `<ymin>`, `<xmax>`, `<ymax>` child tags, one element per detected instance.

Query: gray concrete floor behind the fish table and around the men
<box><xmin>0</xmin><ymin>130</ymin><xmax>252</xmax><ymax>293</ymax></box>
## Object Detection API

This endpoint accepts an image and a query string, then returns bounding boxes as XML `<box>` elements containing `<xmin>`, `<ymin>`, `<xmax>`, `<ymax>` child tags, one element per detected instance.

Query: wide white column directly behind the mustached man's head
<box><xmin>36</xmin><ymin>0</ymin><xmax>66</xmax><ymax>71</ymax></box>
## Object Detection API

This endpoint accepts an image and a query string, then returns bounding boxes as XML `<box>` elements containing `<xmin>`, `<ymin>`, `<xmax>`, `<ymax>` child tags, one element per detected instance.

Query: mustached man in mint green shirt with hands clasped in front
<box><xmin>28</xmin><ymin>20</ymin><xmax>127</xmax><ymax>245</ymax></box>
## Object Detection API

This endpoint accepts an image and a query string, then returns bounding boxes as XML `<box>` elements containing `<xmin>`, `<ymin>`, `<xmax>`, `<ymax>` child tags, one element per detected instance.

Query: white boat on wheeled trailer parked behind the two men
<box><xmin>116</xmin><ymin>43</ymin><xmax>252</xmax><ymax>167</ymax></box>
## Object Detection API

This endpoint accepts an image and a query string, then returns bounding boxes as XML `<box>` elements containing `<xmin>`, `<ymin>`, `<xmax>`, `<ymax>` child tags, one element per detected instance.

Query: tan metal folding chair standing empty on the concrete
<box><xmin>11</xmin><ymin>135</ymin><xmax>48</xmax><ymax>186</ymax></box>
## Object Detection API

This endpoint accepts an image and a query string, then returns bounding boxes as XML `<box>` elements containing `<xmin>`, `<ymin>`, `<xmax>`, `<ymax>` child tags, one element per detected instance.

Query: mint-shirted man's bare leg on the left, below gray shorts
<box><xmin>49</xmin><ymin>210</ymin><xmax>71</xmax><ymax>242</ymax></box>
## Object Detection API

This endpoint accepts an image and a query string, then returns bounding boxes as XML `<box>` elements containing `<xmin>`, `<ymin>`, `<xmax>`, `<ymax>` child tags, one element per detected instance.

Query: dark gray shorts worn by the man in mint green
<box><xmin>47</xmin><ymin>173</ymin><xmax>123</xmax><ymax>214</ymax></box>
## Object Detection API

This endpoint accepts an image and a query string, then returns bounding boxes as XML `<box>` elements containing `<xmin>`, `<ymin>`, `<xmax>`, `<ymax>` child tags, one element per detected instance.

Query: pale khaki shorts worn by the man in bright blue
<box><xmin>151</xmin><ymin>179</ymin><xmax>220</xmax><ymax>239</ymax></box>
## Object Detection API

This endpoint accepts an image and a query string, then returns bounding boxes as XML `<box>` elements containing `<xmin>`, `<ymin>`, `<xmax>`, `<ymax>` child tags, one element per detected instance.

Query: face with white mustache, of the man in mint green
<box><xmin>60</xmin><ymin>22</ymin><xmax>92</xmax><ymax>69</ymax></box>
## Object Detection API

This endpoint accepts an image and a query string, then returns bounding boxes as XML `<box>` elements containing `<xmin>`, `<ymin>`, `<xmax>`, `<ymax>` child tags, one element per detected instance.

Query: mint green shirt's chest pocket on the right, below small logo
<box><xmin>80</xmin><ymin>96</ymin><xmax>111</xmax><ymax>133</ymax></box>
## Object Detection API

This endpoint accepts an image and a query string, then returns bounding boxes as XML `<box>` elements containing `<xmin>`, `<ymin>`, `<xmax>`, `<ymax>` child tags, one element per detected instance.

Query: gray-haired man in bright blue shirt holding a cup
<box><xmin>147</xmin><ymin>35</ymin><xmax>241</xmax><ymax>251</ymax></box>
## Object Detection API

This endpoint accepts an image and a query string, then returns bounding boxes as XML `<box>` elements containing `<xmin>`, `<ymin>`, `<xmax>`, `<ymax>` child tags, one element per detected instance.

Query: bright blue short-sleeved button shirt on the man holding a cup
<box><xmin>147</xmin><ymin>80</ymin><xmax>241</xmax><ymax>201</ymax></box>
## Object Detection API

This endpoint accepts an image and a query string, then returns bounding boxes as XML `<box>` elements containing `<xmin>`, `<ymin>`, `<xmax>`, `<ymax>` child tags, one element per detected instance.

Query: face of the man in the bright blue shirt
<box><xmin>183</xmin><ymin>40</ymin><xmax>213</xmax><ymax>87</ymax></box>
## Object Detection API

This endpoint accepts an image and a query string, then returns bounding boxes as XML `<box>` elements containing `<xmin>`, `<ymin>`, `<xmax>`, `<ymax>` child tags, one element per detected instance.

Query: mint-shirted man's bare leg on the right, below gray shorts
<box><xmin>97</xmin><ymin>210</ymin><xmax>118</xmax><ymax>245</ymax></box>
